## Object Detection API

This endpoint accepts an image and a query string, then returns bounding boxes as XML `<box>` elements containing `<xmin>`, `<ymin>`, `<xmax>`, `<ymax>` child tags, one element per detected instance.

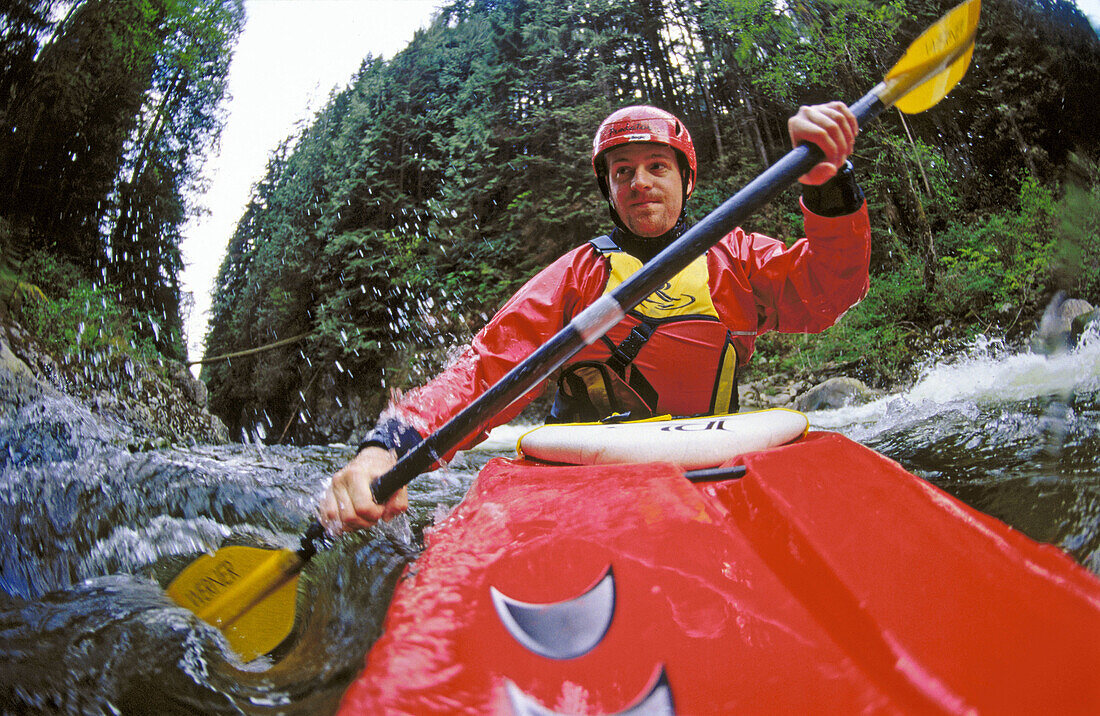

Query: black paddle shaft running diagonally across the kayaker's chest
<box><xmin>371</xmin><ymin>94</ymin><xmax>886</xmax><ymax>505</ymax></box>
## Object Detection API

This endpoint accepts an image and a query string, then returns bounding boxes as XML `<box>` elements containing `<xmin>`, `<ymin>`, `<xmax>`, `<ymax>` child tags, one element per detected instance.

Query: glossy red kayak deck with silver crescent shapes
<box><xmin>342</xmin><ymin>432</ymin><xmax>1100</xmax><ymax>715</ymax></box>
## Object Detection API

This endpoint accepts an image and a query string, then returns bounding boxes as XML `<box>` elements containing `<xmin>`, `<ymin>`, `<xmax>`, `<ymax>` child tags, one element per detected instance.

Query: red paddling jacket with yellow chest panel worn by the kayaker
<box><xmin>363</xmin><ymin>195</ymin><xmax>870</xmax><ymax>453</ymax></box>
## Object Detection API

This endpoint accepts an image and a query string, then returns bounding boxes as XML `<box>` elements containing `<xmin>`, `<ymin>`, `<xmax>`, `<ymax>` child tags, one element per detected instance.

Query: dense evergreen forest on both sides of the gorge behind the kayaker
<box><xmin>0</xmin><ymin>0</ymin><xmax>1100</xmax><ymax>441</ymax></box>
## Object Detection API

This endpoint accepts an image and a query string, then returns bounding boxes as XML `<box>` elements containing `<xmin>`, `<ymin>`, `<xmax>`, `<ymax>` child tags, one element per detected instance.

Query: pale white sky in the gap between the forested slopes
<box><xmin>182</xmin><ymin>0</ymin><xmax>440</xmax><ymax>360</ymax></box>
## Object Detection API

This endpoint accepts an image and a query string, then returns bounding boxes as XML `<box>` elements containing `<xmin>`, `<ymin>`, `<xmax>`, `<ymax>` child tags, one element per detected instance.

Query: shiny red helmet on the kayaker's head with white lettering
<box><xmin>592</xmin><ymin>104</ymin><xmax>697</xmax><ymax>201</ymax></box>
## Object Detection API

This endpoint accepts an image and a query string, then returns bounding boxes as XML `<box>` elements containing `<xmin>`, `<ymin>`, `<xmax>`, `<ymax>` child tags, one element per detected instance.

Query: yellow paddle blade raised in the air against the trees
<box><xmin>876</xmin><ymin>0</ymin><xmax>981</xmax><ymax>114</ymax></box>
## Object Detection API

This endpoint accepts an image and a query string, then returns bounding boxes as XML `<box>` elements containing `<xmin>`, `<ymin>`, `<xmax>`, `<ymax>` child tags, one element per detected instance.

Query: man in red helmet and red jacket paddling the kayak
<box><xmin>321</xmin><ymin>102</ymin><xmax>870</xmax><ymax>530</ymax></box>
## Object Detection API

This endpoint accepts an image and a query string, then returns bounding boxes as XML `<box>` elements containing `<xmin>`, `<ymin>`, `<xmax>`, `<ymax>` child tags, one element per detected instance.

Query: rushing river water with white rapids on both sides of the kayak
<box><xmin>0</xmin><ymin>333</ymin><xmax>1100</xmax><ymax>714</ymax></box>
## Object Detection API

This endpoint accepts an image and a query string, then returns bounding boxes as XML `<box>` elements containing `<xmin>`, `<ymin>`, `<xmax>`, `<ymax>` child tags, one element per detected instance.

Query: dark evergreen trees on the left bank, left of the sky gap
<box><xmin>0</xmin><ymin>0</ymin><xmax>244</xmax><ymax>360</ymax></box>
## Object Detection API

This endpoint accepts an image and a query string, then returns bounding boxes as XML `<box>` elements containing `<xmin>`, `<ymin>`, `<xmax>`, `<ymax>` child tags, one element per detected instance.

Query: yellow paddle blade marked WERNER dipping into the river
<box><xmin>167</xmin><ymin>546</ymin><xmax>304</xmax><ymax>661</ymax></box>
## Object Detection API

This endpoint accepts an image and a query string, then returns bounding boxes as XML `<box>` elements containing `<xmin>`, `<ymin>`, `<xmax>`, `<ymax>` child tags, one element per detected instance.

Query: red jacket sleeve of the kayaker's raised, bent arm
<box><xmin>708</xmin><ymin>202</ymin><xmax>871</xmax><ymax>364</ymax></box>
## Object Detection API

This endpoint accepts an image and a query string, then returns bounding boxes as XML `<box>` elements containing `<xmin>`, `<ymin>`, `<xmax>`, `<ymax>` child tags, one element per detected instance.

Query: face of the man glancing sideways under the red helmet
<box><xmin>606</xmin><ymin>143</ymin><xmax>683</xmax><ymax>238</ymax></box>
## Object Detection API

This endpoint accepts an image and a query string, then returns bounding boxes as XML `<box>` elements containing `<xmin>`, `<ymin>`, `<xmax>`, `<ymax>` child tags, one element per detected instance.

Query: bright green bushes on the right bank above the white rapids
<box><xmin>757</xmin><ymin>173</ymin><xmax>1100</xmax><ymax>382</ymax></box>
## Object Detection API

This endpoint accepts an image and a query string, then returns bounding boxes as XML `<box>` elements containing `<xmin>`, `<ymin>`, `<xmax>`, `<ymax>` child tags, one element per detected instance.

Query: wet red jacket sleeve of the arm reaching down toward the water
<box><xmin>383</xmin><ymin>244</ymin><xmax>607</xmax><ymax>458</ymax></box>
